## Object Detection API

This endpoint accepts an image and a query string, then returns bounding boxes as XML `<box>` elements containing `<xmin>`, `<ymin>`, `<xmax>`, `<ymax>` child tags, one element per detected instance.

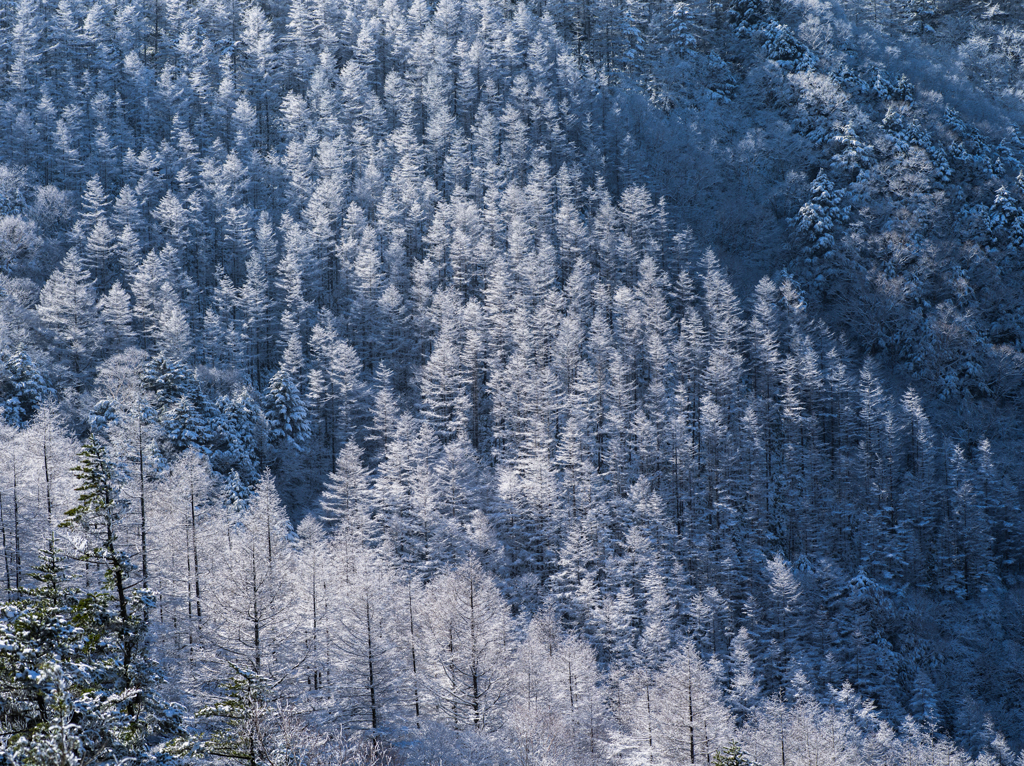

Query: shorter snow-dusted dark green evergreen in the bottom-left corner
<box><xmin>0</xmin><ymin>538</ymin><xmax>186</xmax><ymax>766</ymax></box>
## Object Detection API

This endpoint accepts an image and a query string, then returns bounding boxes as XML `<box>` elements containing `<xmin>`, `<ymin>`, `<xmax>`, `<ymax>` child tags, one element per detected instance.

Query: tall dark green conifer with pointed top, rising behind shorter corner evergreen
<box><xmin>35</xmin><ymin>437</ymin><xmax>187</xmax><ymax>763</ymax></box>
